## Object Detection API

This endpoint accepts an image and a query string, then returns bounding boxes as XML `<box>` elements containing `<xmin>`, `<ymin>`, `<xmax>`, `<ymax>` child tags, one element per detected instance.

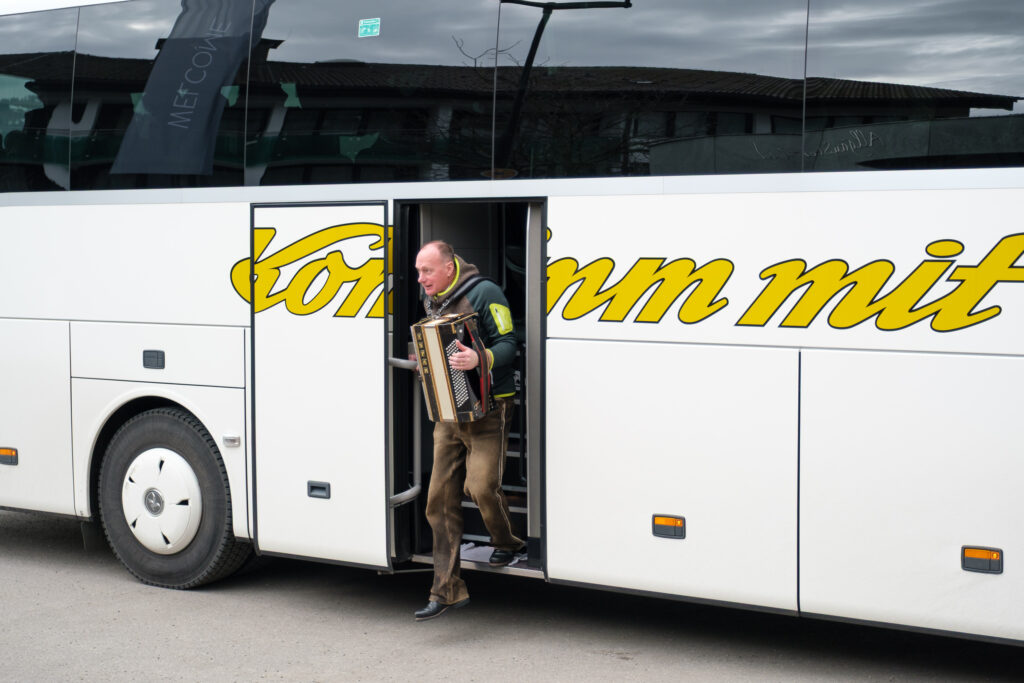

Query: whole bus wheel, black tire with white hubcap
<box><xmin>99</xmin><ymin>408</ymin><xmax>252</xmax><ymax>589</ymax></box>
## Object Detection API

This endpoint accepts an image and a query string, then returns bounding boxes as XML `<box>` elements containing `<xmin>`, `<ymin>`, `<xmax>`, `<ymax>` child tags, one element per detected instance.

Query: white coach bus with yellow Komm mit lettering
<box><xmin>0</xmin><ymin>0</ymin><xmax>1024</xmax><ymax>642</ymax></box>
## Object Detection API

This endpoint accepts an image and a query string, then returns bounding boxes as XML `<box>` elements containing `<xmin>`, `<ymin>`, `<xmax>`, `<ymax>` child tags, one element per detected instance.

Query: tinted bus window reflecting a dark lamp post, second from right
<box><xmin>492</xmin><ymin>0</ymin><xmax>807</xmax><ymax>177</ymax></box>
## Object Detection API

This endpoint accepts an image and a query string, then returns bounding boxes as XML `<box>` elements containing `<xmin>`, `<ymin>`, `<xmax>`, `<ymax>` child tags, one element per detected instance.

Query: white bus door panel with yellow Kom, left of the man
<box><xmin>252</xmin><ymin>202</ymin><xmax>389</xmax><ymax>567</ymax></box>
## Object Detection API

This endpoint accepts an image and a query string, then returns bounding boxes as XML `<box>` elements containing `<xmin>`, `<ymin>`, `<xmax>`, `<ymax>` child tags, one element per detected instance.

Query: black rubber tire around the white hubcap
<box><xmin>99</xmin><ymin>408</ymin><xmax>252</xmax><ymax>589</ymax></box>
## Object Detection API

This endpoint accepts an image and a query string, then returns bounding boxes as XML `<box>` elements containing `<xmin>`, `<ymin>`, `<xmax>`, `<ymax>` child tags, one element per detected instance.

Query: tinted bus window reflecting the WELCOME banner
<box><xmin>72</xmin><ymin>0</ymin><xmax>256</xmax><ymax>189</ymax></box>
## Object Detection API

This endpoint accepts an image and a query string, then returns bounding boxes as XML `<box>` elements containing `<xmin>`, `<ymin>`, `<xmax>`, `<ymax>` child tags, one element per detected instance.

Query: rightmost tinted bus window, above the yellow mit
<box><xmin>804</xmin><ymin>0</ymin><xmax>1024</xmax><ymax>170</ymax></box>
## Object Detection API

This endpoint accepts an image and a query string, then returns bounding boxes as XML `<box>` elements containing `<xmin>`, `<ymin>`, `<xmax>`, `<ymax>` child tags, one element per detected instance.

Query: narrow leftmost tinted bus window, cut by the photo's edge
<box><xmin>0</xmin><ymin>9</ymin><xmax>78</xmax><ymax>191</ymax></box>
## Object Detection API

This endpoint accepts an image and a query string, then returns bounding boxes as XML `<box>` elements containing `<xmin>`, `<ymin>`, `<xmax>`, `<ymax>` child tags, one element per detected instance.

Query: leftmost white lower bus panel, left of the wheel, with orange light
<box><xmin>0</xmin><ymin>319</ymin><xmax>75</xmax><ymax>515</ymax></box>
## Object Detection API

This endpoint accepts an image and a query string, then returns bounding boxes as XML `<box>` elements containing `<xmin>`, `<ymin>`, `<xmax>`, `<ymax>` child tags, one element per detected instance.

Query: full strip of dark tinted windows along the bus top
<box><xmin>0</xmin><ymin>0</ymin><xmax>1024</xmax><ymax>191</ymax></box>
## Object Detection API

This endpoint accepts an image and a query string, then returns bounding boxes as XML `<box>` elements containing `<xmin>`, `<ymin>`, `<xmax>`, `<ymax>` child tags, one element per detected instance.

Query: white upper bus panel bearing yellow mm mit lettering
<box><xmin>547</xmin><ymin>183</ymin><xmax>1024</xmax><ymax>355</ymax></box>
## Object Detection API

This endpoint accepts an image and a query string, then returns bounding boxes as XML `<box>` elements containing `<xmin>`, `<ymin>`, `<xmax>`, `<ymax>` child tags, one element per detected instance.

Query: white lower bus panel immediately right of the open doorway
<box><xmin>546</xmin><ymin>340</ymin><xmax>798</xmax><ymax>610</ymax></box>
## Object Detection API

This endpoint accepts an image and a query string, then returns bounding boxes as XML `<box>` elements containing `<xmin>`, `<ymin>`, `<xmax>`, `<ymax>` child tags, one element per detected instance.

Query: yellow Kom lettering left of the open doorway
<box><xmin>231</xmin><ymin>223</ymin><xmax>391</xmax><ymax>317</ymax></box>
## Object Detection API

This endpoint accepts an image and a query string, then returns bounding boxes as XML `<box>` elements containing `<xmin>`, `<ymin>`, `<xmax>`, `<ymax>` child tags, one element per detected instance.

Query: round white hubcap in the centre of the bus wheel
<box><xmin>121</xmin><ymin>449</ymin><xmax>203</xmax><ymax>555</ymax></box>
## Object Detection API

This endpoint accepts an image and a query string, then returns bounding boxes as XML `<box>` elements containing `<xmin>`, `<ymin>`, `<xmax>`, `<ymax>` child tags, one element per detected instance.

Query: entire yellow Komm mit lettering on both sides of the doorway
<box><xmin>231</xmin><ymin>223</ymin><xmax>1024</xmax><ymax>332</ymax></box>
